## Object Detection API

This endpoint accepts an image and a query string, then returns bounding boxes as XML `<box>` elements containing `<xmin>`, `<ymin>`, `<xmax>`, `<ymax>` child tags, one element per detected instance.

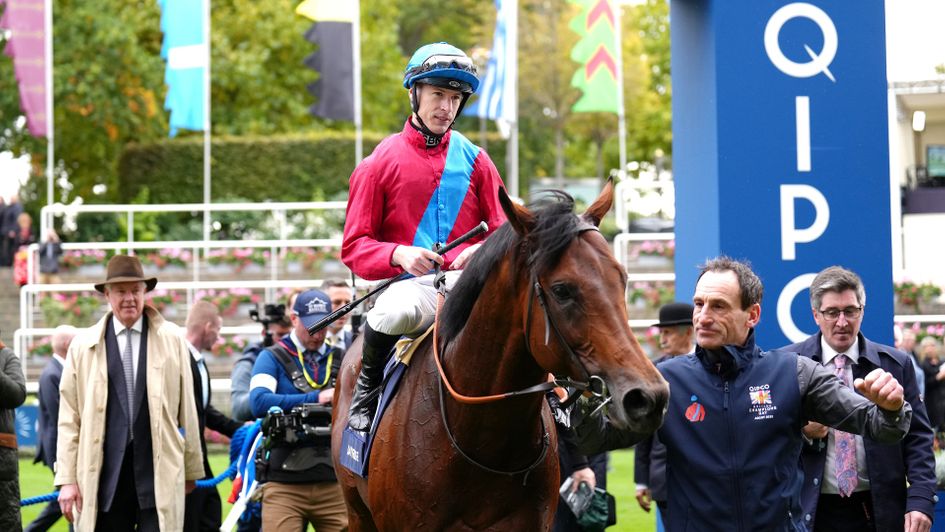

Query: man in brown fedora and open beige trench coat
<box><xmin>55</xmin><ymin>255</ymin><xmax>204</xmax><ymax>531</ymax></box>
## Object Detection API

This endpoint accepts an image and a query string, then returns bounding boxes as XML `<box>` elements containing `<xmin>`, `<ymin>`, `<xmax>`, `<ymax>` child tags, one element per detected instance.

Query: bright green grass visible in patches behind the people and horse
<box><xmin>20</xmin><ymin>450</ymin><xmax>656</xmax><ymax>532</ymax></box>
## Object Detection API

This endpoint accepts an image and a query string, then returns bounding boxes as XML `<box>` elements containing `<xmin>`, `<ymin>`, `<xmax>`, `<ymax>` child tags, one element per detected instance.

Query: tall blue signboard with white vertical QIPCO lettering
<box><xmin>670</xmin><ymin>0</ymin><xmax>893</xmax><ymax>349</ymax></box>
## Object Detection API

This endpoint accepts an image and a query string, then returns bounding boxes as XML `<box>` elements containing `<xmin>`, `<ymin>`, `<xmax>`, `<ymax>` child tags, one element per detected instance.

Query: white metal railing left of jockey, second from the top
<box><xmin>26</xmin><ymin>238</ymin><xmax>341</xmax><ymax>284</ymax></box>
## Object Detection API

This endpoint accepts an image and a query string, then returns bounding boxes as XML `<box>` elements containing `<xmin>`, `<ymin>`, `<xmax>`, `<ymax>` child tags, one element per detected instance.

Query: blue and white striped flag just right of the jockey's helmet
<box><xmin>464</xmin><ymin>0</ymin><xmax>518</xmax><ymax>125</ymax></box>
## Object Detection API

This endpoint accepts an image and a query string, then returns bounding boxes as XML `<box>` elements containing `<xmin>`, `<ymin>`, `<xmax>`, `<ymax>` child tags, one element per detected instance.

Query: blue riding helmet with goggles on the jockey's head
<box><xmin>404</xmin><ymin>42</ymin><xmax>479</xmax><ymax>96</ymax></box>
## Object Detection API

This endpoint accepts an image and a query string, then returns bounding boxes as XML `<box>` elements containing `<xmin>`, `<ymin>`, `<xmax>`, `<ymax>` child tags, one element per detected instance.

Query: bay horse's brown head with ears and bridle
<box><xmin>499</xmin><ymin>181</ymin><xmax>669</xmax><ymax>432</ymax></box>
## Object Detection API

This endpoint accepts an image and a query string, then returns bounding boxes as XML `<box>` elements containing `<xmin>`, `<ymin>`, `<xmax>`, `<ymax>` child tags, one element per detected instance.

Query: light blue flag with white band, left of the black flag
<box><xmin>157</xmin><ymin>0</ymin><xmax>208</xmax><ymax>137</ymax></box>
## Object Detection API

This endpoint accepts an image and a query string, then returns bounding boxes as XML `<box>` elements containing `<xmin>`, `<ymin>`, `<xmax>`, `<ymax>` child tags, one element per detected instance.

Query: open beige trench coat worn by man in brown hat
<box><xmin>55</xmin><ymin>306</ymin><xmax>204</xmax><ymax>532</ymax></box>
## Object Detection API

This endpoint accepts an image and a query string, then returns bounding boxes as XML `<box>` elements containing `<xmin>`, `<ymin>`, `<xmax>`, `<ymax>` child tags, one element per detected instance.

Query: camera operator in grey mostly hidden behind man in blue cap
<box><xmin>230</xmin><ymin>293</ymin><xmax>297</xmax><ymax>421</ymax></box>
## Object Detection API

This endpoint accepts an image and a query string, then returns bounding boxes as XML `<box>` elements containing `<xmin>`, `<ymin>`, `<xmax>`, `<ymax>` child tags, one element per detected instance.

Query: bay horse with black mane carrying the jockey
<box><xmin>332</xmin><ymin>182</ymin><xmax>669</xmax><ymax>531</ymax></box>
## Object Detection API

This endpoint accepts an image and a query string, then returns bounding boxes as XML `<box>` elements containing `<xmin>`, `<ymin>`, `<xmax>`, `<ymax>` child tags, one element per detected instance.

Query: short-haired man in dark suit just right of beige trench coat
<box><xmin>184</xmin><ymin>301</ymin><xmax>241</xmax><ymax>532</ymax></box>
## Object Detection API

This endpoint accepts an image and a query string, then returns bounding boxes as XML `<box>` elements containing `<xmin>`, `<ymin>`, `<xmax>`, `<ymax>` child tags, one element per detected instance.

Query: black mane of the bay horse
<box><xmin>439</xmin><ymin>190</ymin><xmax>580</xmax><ymax>342</ymax></box>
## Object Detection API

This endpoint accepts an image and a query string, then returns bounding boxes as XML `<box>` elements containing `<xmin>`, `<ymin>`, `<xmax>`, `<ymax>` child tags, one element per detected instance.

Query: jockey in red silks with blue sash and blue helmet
<box><xmin>341</xmin><ymin>42</ymin><xmax>505</xmax><ymax>431</ymax></box>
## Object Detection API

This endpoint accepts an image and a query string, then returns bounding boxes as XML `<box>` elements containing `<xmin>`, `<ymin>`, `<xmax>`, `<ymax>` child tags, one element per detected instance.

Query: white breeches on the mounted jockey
<box><xmin>367</xmin><ymin>270</ymin><xmax>462</xmax><ymax>336</ymax></box>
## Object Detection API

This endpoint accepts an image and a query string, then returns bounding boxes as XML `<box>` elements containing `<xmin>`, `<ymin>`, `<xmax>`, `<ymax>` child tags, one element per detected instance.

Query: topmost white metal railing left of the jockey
<box><xmin>40</xmin><ymin>201</ymin><xmax>347</xmax><ymax>242</ymax></box>
